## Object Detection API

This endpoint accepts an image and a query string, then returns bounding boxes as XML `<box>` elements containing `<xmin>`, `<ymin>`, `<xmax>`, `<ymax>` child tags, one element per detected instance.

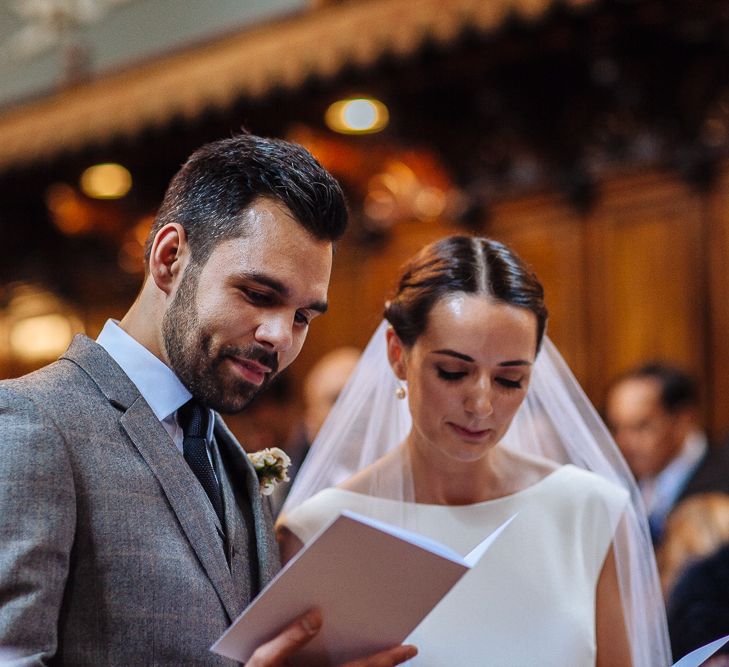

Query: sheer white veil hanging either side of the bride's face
<box><xmin>282</xmin><ymin>321</ymin><xmax>671</xmax><ymax>667</ymax></box>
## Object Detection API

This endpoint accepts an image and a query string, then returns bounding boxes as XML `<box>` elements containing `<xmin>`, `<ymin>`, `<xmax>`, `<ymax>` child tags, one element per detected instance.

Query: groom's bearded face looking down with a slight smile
<box><xmin>162</xmin><ymin>199</ymin><xmax>332</xmax><ymax>414</ymax></box>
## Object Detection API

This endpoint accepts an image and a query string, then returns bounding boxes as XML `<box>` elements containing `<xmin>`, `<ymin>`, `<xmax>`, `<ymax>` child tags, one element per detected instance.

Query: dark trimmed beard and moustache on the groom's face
<box><xmin>162</xmin><ymin>264</ymin><xmax>278</xmax><ymax>414</ymax></box>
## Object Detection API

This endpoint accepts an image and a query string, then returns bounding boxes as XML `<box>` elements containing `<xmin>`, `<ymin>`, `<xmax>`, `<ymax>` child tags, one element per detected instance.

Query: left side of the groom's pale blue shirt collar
<box><xmin>96</xmin><ymin>320</ymin><xmax>192</xmax><ymax>422</ymax></box>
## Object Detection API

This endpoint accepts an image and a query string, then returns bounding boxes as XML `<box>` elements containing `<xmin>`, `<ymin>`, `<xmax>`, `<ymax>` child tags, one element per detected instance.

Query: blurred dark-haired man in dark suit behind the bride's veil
<box><xmin>606</xmin><ymin>362</ymin><xmax>729</xmax><ymax>544</ymax></box>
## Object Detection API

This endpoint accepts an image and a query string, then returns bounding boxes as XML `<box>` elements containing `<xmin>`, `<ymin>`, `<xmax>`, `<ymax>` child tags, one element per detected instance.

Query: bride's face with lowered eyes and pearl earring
<box><xmin>388</xmin><ymin>293</ymin><xmax>537</xmax><ymax>465</ymax></box>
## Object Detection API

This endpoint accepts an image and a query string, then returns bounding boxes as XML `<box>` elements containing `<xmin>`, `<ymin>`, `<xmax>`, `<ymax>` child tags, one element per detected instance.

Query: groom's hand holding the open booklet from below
<box><xmin>246</xmin><ymin>609</ymin><xmax>417</xmax><ymax>667</ymax></box>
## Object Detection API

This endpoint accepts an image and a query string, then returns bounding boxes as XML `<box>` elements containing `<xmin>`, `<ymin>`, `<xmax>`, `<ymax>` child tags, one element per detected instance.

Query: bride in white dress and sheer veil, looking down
<box><xmin>278</xmin><ymin>236</ymin><xmax>670</xmax><ymax>667</ymax></box>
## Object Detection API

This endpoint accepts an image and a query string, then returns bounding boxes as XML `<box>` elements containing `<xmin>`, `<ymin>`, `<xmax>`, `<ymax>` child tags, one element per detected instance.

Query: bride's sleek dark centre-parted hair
<box><xmin>385</xmin><ymin>236</ymin><xmax>547</xmax><ymax>350</ymax></box>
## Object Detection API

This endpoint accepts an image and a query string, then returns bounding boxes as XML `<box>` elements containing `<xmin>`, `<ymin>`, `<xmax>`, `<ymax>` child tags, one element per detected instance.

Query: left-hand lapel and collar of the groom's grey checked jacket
<box><xmin>64</xmin><ymin>336</ymin><xmax>240</xmax><ymax>620</ymax></box>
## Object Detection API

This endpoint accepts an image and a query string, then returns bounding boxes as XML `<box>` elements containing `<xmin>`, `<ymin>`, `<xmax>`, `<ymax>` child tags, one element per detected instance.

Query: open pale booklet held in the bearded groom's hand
<box><xmin>211</xmin><ymin>510</ymin><xmax>516</xmax><ymax>667</ymax></box>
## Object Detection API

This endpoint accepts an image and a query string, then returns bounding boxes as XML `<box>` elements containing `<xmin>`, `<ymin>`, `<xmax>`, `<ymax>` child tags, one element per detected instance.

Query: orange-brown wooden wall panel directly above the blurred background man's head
<box><xmin>586</xmin><ymin>175</ymin><xmax>706</xmax><ymax>410</ymax></box>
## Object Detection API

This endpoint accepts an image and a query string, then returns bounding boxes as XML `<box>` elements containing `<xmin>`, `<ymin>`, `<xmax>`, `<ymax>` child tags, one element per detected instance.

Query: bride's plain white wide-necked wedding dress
<box><xmin>283</xmin><ymin>465</ymin><xmax>628</xmax><ymax>667</ymax></box>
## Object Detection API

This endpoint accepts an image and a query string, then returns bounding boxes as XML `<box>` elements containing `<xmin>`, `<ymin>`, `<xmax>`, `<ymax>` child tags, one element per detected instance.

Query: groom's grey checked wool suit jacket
<box><xmin>0</xmin><ymin>336</ymin><xmax>279</xmax><ymax>665</ymax></box>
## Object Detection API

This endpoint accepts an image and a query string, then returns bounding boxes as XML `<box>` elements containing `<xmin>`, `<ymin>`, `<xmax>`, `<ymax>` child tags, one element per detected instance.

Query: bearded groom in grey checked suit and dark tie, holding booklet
<box><xmin>0</xmin><ymin>135</ymin><xmax>414</xmax><ymax>667</ymax></box>
